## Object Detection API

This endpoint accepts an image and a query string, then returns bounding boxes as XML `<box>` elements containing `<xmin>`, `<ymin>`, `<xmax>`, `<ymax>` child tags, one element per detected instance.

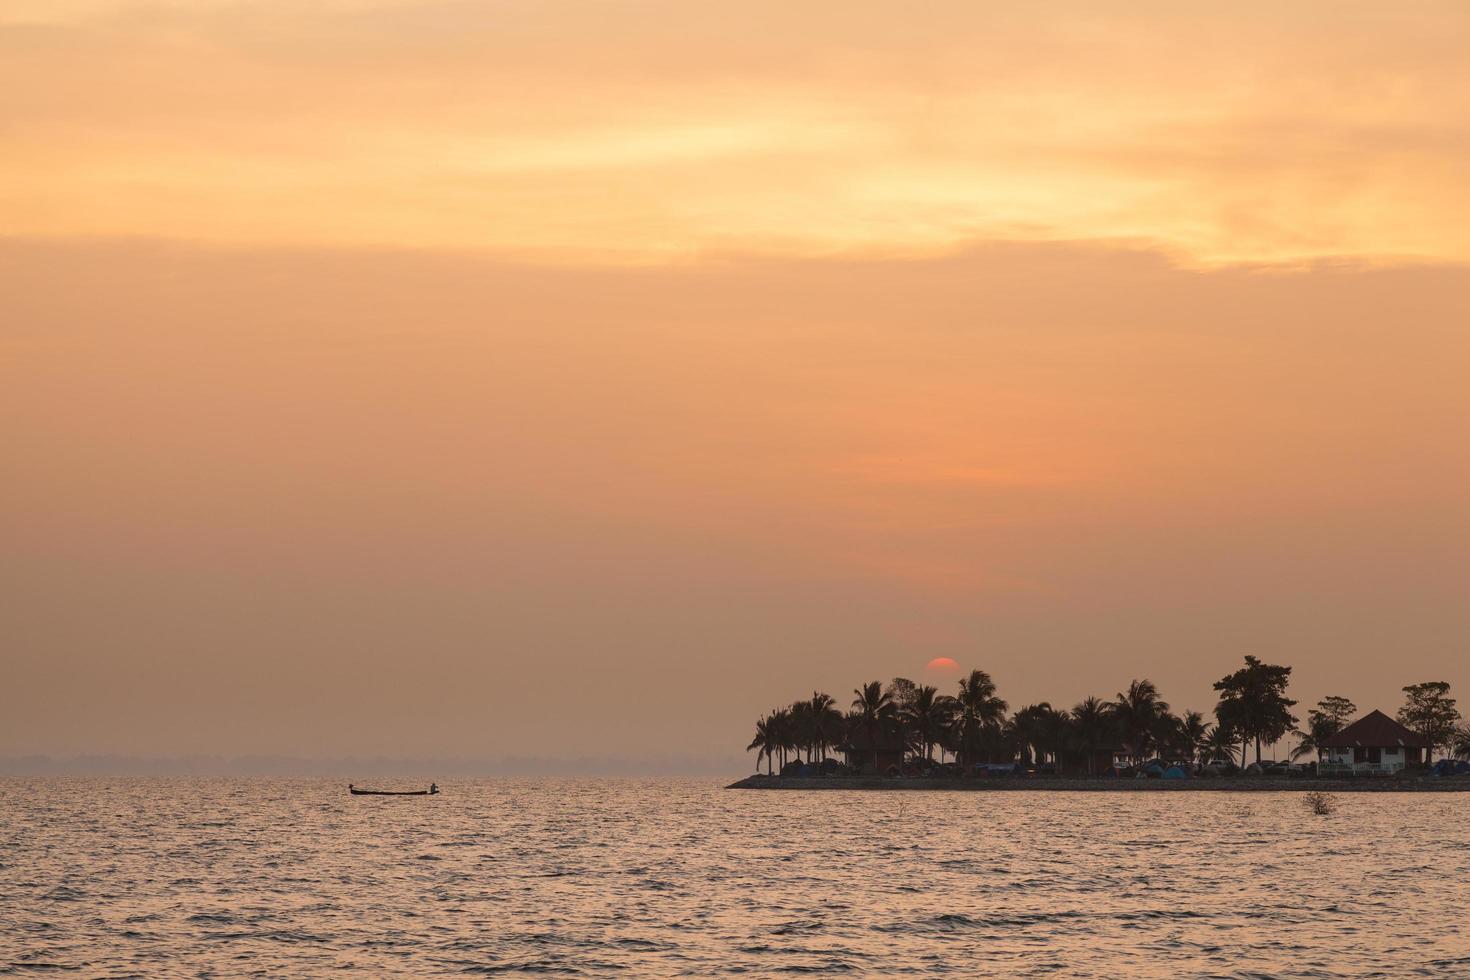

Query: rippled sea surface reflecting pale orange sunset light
<box><xmin>0</xmin><ymin>779</ymin><xmax>1470</xmax><ymax>977</ymax></box>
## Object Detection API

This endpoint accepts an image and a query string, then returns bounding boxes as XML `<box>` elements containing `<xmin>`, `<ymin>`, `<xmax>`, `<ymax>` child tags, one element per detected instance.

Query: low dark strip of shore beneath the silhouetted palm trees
<box><xmin>725</xmin><ymin>776</ymin><xmax>1470</xmax><ymax>793</ymax></box>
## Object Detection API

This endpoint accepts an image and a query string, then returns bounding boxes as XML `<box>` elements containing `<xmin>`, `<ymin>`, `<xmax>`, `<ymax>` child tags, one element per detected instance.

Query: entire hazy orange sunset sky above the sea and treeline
<box><xmin>0</xmin><ymin>0</ymin><xmax>1470</xmax><ymax>758</ymax></box>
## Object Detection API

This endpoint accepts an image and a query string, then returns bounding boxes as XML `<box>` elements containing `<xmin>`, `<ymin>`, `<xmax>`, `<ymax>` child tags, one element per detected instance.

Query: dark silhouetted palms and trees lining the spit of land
<box><xmin>747</xmin><ymin>657</ymin><xmax>1470</xmax><ymax>774</ymax></box>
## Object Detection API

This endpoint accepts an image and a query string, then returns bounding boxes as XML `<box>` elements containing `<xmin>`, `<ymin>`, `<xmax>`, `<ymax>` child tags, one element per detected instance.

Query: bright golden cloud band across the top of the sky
<box><xmin>0</xmin><ymin>0</ymin><xmax>1470</xmax><ymax>263</ymax></box>
